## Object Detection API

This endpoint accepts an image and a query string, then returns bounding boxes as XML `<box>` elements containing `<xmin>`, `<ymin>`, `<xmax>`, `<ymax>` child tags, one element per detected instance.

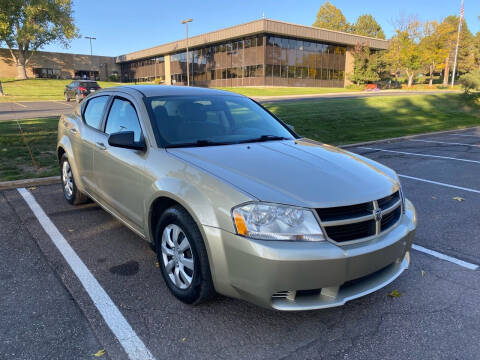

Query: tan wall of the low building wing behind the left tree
<box><xmin>0</xmin><ymin>49</ymin><xmax>120</xmax><ymax>80</ymax></box>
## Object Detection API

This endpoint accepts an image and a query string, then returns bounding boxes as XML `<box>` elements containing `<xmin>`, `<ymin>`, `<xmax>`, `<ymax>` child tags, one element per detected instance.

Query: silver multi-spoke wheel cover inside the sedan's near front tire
<box><xmin>161</xmin><ymin>224</ymin><xmax>195</xmax><ymax>289</ymax></box>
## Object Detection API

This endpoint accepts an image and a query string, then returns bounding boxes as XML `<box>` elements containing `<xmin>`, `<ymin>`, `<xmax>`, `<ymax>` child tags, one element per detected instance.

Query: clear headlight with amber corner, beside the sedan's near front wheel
<box><xmin>232</xmin><ymin>203</ymin><xmax>325</xmax><ymax>241</ymax></box>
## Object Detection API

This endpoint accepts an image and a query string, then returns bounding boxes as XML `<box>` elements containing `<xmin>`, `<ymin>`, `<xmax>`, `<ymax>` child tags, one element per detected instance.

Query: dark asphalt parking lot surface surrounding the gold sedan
<box><xmin>0</xmin><ymin>127</ymin><xmax>480</xmax><ymax>359</ymax></box>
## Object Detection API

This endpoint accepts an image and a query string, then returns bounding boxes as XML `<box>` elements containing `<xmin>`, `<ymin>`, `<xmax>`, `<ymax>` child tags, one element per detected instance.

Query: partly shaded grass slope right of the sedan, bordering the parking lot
<box><xmin>265</xmin><ymin>93</ymin><xmax>480</xmax><ymax>145</ymax></box>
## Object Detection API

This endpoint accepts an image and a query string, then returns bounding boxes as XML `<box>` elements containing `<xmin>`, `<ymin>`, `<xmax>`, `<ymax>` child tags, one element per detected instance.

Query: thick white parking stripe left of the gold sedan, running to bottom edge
<box><xmin>18</xmin><ymin>188</ymin><xmax>154</xmax><ymax>360</ymax></box>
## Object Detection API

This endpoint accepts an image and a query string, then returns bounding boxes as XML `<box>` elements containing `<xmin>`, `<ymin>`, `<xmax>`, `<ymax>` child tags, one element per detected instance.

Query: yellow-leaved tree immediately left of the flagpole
<box><xmin>420</xmin><ymin>21</ymin><xmax>448</xmax><ymax>86</ymax></box>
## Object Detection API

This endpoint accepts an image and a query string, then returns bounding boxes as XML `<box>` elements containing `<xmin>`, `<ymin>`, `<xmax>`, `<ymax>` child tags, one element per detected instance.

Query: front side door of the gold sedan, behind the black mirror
<box><xmin>93</xmin><ymin>95</ymin><xmax>148</xmax><ymax>233</ymax></box>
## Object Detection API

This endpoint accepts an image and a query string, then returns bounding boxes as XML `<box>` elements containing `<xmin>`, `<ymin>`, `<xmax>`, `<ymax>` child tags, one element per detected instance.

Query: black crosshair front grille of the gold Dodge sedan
<box><xmin>316</xmin><ymin>191</ymin><xmax>402</xmax><ymax>243</ymax></box>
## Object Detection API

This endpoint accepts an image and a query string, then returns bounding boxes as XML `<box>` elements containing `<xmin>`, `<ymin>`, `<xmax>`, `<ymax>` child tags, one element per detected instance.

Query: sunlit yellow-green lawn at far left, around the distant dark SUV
<box><xmin>0</xmin><ymin>79</ymin><xmax>123</xmax><ymax>102</ymax></box>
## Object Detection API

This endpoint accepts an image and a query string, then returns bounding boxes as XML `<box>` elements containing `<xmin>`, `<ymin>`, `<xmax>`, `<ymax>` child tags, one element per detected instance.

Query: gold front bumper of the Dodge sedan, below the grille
<box><xmin>204</xmin><ymin>200</ymin><xmax>417</xmax><ymax>310</ymax></box>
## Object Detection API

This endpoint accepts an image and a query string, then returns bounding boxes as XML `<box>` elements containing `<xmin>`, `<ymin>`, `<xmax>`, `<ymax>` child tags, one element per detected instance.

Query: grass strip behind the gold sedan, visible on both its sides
<box><xmin>0</xmin><ymin>94</ymin><xmax>480</xmax><ymax>181</ymax></box>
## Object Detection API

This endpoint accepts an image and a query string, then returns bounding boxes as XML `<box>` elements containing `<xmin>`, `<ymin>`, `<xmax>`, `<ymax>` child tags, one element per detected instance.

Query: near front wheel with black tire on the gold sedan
<box><xmin>155</xmin><ymin>206</ymin><xmax>215</xmax><ymax>305</ymax></box>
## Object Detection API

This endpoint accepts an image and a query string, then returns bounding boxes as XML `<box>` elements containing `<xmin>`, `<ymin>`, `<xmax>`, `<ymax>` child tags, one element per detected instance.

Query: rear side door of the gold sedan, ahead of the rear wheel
<box><xmin>71</xmin><ymin>95</ymin><xmax>110</xmax><ymax>195</ymax></box>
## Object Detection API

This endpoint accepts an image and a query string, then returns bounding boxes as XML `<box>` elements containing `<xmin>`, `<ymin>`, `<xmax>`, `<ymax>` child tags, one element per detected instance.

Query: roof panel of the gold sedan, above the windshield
<box><xmin>101</xmin><ymin>85</ymin><xmax>242</xmax><ymax>97</ymax></box>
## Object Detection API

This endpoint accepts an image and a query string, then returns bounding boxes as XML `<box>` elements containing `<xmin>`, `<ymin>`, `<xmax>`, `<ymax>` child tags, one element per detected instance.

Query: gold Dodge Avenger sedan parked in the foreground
<box><xmin>57</xmin><ymin>85</ymin><xmax>417</xmax><ymax>310</ymax></box>
